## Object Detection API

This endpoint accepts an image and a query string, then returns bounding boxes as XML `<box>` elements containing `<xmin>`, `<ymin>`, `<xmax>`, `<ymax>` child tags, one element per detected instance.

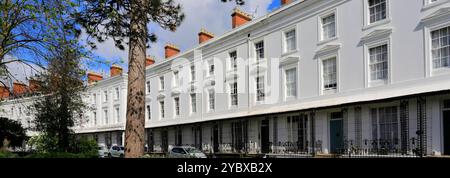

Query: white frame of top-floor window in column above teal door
<box><xmin>317</xmin><ymin>9</ymin><xmax>339</xmax><ymax>45</ymax></box>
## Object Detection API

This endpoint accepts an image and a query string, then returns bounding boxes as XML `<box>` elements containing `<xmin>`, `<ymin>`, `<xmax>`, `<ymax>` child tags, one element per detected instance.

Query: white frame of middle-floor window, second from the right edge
<box><xmin>364</xmin><ymin>36</ymin><xmax>393</xmax><ymax>88</ymax></box>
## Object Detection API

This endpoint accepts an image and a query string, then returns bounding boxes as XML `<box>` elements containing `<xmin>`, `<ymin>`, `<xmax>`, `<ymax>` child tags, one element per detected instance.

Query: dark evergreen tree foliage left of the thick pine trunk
<box><xmin>34</xmin><ymin>44</ymin><xmax>87</xmax><ymax>152</ymax></box>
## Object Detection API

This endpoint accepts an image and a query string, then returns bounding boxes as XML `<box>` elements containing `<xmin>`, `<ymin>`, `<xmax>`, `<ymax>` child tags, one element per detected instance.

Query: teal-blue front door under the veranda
<box><xmin>330</xmin><ymin>119</ymin><xmax>344</xmax><ymax>153</ymax></box>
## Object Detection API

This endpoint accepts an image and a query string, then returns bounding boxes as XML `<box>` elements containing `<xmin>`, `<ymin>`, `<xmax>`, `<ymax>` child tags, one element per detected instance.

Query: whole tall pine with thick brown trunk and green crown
<box><xmin>77</xmin><ymin>0</ymin><xmax>184</xmax><ymax>158</ymax></box>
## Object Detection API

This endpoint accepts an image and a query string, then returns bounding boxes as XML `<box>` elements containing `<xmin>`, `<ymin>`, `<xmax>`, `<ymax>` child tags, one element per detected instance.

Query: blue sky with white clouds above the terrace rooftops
<box><xmin>8</xmin><ymin>0</ymin><xmax>280</xmax><ymax>83</ymax></box>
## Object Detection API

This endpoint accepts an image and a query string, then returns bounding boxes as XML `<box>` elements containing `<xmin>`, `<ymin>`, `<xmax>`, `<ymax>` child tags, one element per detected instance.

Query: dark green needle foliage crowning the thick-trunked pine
<box><xmin>75</xmin><ymin>0</ymin><xmax>184</xmax><ymax>50</ymax></box>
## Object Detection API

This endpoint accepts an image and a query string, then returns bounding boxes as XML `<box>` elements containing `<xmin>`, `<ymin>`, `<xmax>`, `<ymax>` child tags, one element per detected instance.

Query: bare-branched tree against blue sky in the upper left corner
<box><xmin>0</xmin><ymin>0</ymin><xmax>79</xmax><ymax>88</ymax></box>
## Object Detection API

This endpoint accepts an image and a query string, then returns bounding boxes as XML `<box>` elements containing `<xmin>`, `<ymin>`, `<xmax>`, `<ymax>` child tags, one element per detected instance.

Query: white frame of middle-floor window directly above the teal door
<box><xmin>318</xmin><ymin>52</ymin><xmax>341</xmax><ymax>95</ymax></box>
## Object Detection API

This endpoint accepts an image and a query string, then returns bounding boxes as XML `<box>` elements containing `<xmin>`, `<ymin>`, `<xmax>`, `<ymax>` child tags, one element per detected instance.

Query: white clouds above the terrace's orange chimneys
<box><xmin>87</xmin><ymin>0</ymin><xmax>272</xmax><ymax>67</ymax></box>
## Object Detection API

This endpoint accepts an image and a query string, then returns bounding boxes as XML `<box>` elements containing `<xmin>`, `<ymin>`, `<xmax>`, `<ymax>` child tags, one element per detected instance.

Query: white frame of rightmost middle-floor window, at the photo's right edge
<box><xmin>424</xmin><ymin>22</ymin><xmax>450</xmax><ymax>77</ymax></box>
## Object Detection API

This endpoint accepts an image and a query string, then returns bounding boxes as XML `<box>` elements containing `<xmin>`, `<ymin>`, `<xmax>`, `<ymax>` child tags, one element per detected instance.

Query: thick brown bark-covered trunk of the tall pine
<box><xmin>125</xmin><ymin>0</ymin><xmax>147</xmax><ymax>158</ymax></box>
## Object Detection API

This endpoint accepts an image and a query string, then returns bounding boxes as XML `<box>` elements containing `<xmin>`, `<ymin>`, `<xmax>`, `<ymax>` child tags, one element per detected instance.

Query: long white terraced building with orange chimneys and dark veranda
<box><xmin>1</xmin><ymin>0</ymin><xmax>450</xmax><ymax>156</ymax></box>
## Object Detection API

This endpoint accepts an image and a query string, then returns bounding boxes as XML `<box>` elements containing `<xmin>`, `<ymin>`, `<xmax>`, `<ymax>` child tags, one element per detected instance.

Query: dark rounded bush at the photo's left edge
<box><xmin>0</xmin><ymin>117</ymin><xmax>26</xmax><ymax>148</ymax></box>
